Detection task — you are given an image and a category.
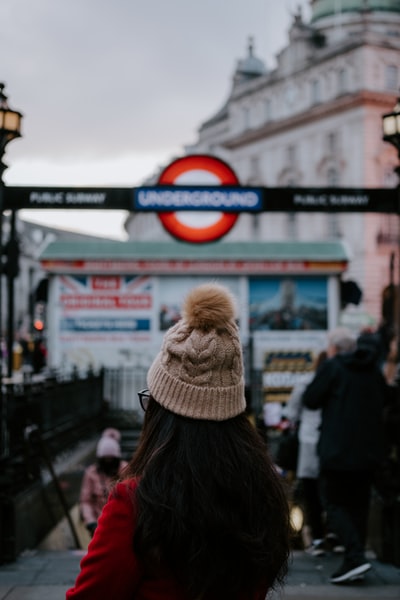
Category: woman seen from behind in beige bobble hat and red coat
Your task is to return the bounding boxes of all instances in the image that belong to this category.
[67,283,290,600]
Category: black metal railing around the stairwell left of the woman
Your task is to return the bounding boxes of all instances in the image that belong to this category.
[0,368,146,564]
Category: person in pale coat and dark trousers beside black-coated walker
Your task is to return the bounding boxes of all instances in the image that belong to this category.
[286,350,328,556]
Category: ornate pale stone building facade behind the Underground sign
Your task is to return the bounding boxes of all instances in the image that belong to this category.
[126,0,400,321]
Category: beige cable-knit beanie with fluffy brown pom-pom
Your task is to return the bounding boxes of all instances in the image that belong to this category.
[147,283,246,421]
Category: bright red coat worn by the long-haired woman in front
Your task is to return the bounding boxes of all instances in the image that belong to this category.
[66,481,266,600]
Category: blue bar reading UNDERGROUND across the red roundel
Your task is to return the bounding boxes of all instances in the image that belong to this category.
[134,185,262,212]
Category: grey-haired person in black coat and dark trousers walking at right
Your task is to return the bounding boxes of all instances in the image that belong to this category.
[303,328,388,583]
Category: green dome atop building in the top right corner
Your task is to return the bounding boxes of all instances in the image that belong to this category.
[311,0,400,23]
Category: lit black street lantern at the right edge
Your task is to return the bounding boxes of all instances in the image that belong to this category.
[382,98,400,378]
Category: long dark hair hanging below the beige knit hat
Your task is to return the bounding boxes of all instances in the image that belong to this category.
[120,399,290,600]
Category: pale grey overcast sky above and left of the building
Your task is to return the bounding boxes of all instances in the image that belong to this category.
[0,0,309,239]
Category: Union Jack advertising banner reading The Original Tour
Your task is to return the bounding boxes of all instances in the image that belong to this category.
[54,275,154,368]
